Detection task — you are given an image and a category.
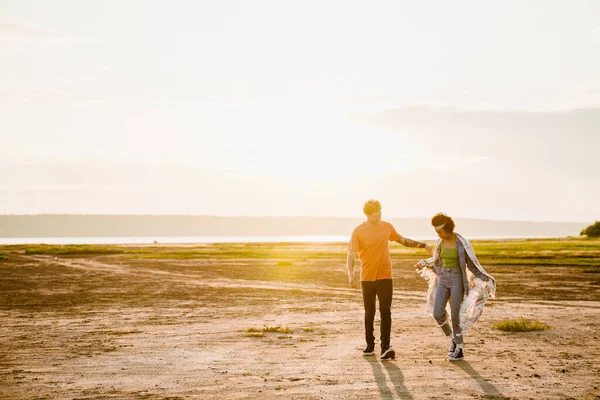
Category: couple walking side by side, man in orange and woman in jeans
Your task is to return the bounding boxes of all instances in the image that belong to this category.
[346,200,496,361]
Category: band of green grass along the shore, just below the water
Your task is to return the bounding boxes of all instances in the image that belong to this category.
[5,237,600,267]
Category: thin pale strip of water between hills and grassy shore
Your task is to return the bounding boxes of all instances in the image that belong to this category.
[0,235,547,245]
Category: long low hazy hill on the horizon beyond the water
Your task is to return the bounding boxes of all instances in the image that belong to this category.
[0,215,588,238]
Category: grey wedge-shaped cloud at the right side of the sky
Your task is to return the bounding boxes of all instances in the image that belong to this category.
[353,106,600,179]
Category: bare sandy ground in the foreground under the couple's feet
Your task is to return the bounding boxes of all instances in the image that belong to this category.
[0,247,600,400]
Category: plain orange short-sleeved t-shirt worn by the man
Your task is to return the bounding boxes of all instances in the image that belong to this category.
[348,221,401,281]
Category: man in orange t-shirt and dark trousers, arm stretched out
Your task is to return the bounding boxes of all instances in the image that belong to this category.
[346,200,431,360]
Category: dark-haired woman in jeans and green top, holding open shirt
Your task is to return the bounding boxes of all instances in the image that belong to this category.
[415,213,496,361]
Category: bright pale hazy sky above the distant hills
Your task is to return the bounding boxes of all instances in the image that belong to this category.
[0,0,600,222]
